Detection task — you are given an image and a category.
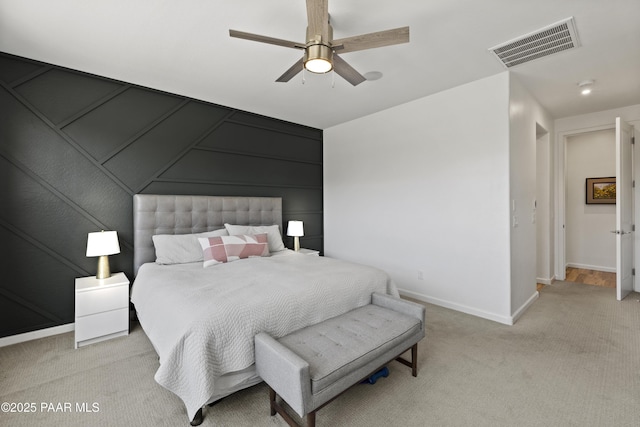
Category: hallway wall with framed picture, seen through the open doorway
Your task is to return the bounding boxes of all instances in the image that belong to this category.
[565,129,616,272]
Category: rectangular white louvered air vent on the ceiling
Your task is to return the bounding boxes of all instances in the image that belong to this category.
[489,17,580,68]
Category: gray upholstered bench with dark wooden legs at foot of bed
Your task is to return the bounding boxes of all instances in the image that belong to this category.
[255,293,425,427]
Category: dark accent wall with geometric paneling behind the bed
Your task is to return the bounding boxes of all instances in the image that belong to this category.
[0,53,323,337]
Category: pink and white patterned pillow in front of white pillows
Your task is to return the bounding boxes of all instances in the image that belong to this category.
[198,233,269,267]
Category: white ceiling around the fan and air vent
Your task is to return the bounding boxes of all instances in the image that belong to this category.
[0,0,640,129]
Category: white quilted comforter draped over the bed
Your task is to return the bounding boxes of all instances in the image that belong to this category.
[131,251,398,419]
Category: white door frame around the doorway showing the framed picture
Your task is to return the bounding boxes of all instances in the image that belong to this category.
[554,120,616,280]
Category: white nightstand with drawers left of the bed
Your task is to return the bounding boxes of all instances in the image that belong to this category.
[75,273,129,348]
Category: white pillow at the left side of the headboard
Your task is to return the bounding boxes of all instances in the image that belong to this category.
[152,228,229,264]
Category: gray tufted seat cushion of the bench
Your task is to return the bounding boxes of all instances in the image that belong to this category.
[278,305,422,394]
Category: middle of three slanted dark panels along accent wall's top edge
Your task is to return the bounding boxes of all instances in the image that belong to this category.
[63,87,182,161]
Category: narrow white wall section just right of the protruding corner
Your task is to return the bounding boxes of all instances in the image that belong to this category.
[508,74,553,319]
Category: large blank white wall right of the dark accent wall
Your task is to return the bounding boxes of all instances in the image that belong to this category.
[324,72,516,324]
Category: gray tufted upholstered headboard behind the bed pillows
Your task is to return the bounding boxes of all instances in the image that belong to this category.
[133,194,282,274]
